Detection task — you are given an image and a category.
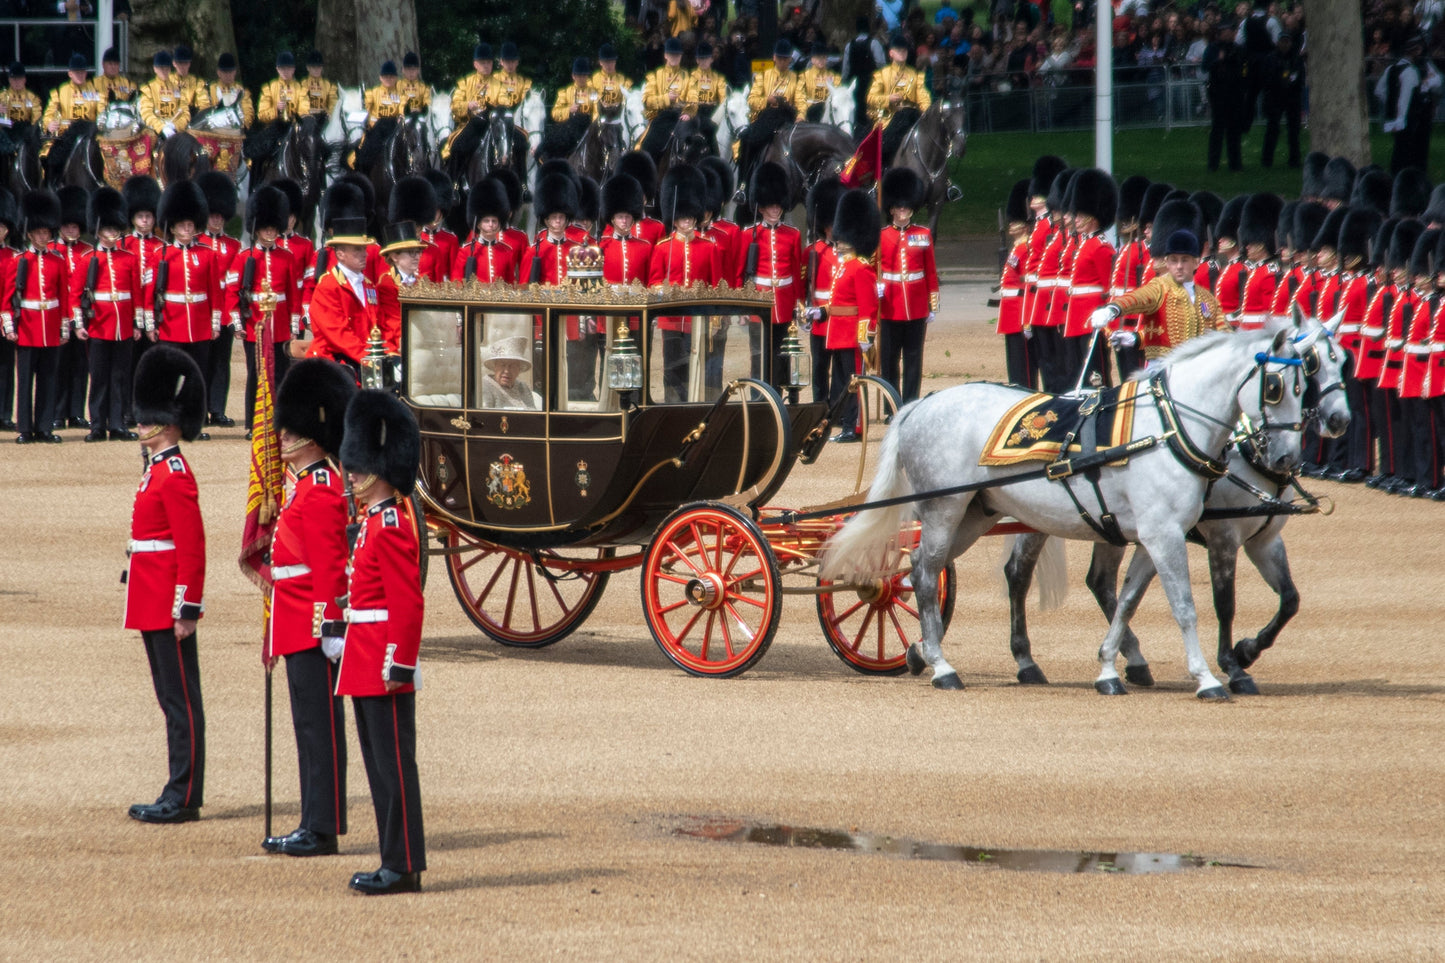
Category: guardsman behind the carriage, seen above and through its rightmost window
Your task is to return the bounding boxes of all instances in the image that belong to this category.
[647,163,719,402]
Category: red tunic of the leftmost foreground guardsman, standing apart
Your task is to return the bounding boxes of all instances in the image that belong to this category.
[126,445,205,632]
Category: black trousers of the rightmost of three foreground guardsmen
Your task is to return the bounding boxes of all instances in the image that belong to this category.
[351,693,426,873]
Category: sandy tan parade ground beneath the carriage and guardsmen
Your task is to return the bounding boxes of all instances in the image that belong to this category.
[0,282,1445,960]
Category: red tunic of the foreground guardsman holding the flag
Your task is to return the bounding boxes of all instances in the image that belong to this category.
[263,461,350,659]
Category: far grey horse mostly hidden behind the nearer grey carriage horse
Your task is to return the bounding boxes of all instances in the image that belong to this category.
[1004,308,1350,696]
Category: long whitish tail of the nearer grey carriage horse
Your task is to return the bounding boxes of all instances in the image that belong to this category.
[818,408,913,581]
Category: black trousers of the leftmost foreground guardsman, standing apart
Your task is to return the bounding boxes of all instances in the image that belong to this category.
[140,629,205,808]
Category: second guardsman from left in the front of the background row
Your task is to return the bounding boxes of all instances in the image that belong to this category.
[71,187,142,441]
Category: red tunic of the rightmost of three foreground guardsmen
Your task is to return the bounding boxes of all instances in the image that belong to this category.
[336,494,423,696]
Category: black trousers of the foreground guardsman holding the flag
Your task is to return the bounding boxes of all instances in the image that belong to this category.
[286,648,347,836]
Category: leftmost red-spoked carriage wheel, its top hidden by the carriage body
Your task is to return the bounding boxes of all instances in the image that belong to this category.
[447,528,613,649]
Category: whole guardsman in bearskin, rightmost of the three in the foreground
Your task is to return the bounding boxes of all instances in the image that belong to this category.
[337,390,426,895]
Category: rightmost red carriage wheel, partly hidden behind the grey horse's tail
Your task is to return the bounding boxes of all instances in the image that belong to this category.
[818,564,958,675]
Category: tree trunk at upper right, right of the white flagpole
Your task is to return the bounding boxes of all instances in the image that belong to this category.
[1305,0,1370,166]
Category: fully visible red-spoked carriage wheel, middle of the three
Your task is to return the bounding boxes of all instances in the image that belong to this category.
[642,505,783,678]
